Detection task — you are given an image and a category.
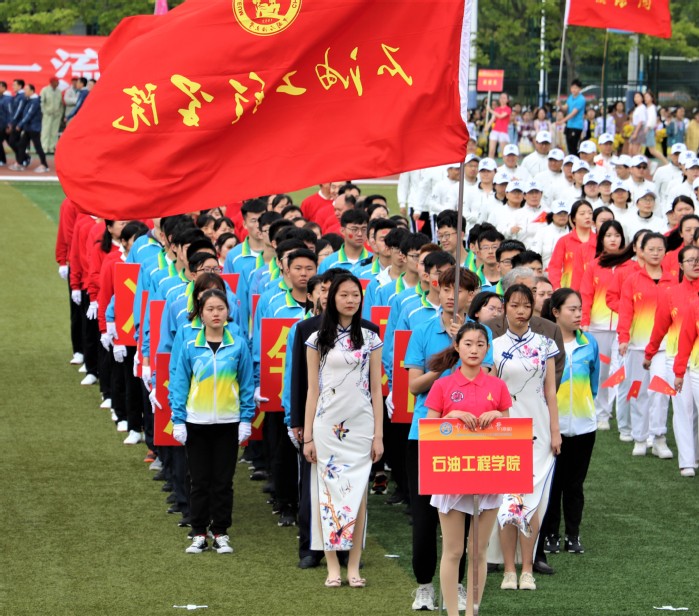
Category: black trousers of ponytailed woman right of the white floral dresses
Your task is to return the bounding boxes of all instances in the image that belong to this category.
[541,432,597,536]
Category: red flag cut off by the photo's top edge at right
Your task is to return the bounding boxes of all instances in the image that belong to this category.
[566,0,672,38]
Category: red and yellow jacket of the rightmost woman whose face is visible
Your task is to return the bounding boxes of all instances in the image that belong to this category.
[646,270,699,359]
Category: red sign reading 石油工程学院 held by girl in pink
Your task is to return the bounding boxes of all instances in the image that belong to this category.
[418,418,534,494]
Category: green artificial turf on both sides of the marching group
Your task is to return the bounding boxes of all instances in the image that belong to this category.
[0,179,699,616]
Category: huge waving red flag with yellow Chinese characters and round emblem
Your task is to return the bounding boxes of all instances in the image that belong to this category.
[56,0,471,219]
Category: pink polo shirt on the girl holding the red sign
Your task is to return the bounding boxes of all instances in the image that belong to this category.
[425,369,512,417]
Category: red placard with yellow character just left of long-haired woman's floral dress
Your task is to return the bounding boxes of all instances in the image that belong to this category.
[260,318,298,412]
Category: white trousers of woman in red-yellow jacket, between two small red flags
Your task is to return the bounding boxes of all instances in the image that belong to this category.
[619,349,669,443]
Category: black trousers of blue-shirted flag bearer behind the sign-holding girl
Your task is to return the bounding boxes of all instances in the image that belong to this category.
[406,441,471,584]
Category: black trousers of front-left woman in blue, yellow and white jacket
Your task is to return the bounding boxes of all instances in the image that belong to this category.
[185,423,239,535]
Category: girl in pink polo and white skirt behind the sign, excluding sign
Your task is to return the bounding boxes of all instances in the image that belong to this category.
[425,321,512,616]
